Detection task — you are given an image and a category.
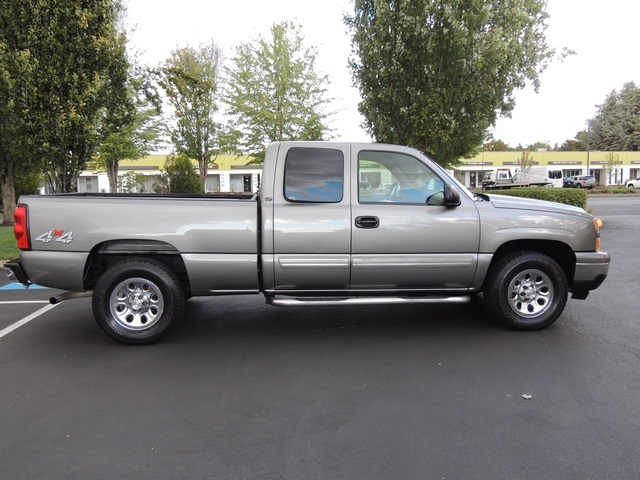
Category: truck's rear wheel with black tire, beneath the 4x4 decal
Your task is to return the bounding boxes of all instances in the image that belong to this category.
[92,258,185,344]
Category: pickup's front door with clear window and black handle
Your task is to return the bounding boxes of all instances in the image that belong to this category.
[350,145,480,293]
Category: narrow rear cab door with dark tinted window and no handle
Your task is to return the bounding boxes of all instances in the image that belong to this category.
[267,144,351,293]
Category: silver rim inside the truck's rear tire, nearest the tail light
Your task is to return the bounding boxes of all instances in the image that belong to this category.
[109,278,164,330]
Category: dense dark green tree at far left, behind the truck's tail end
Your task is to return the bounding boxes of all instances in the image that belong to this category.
[2,0,125,192]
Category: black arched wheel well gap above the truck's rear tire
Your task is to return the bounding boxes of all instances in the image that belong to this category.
[84,240,191,298]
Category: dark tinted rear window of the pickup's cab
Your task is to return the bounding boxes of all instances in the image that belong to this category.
[284,148,344,203]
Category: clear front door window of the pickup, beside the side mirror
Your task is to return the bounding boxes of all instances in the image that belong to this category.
[358,151,444,205]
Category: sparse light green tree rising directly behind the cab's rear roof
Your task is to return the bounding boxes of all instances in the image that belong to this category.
[226,22,331,162]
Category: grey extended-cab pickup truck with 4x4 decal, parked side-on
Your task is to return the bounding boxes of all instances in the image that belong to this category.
[5,142,609,343]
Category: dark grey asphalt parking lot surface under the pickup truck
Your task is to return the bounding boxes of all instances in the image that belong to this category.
[0,195,640,480]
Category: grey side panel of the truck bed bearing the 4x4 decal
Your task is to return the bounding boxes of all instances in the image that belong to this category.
[20,195,258,295]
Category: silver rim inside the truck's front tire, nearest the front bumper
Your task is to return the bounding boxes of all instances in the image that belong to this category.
[509,269,555,318]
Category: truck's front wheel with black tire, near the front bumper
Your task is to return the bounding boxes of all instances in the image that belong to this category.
[484,251,568,330]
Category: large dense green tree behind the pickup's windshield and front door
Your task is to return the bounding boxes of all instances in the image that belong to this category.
[345,0,553,166]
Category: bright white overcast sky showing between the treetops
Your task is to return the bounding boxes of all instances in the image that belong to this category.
[125,0,640,147]
